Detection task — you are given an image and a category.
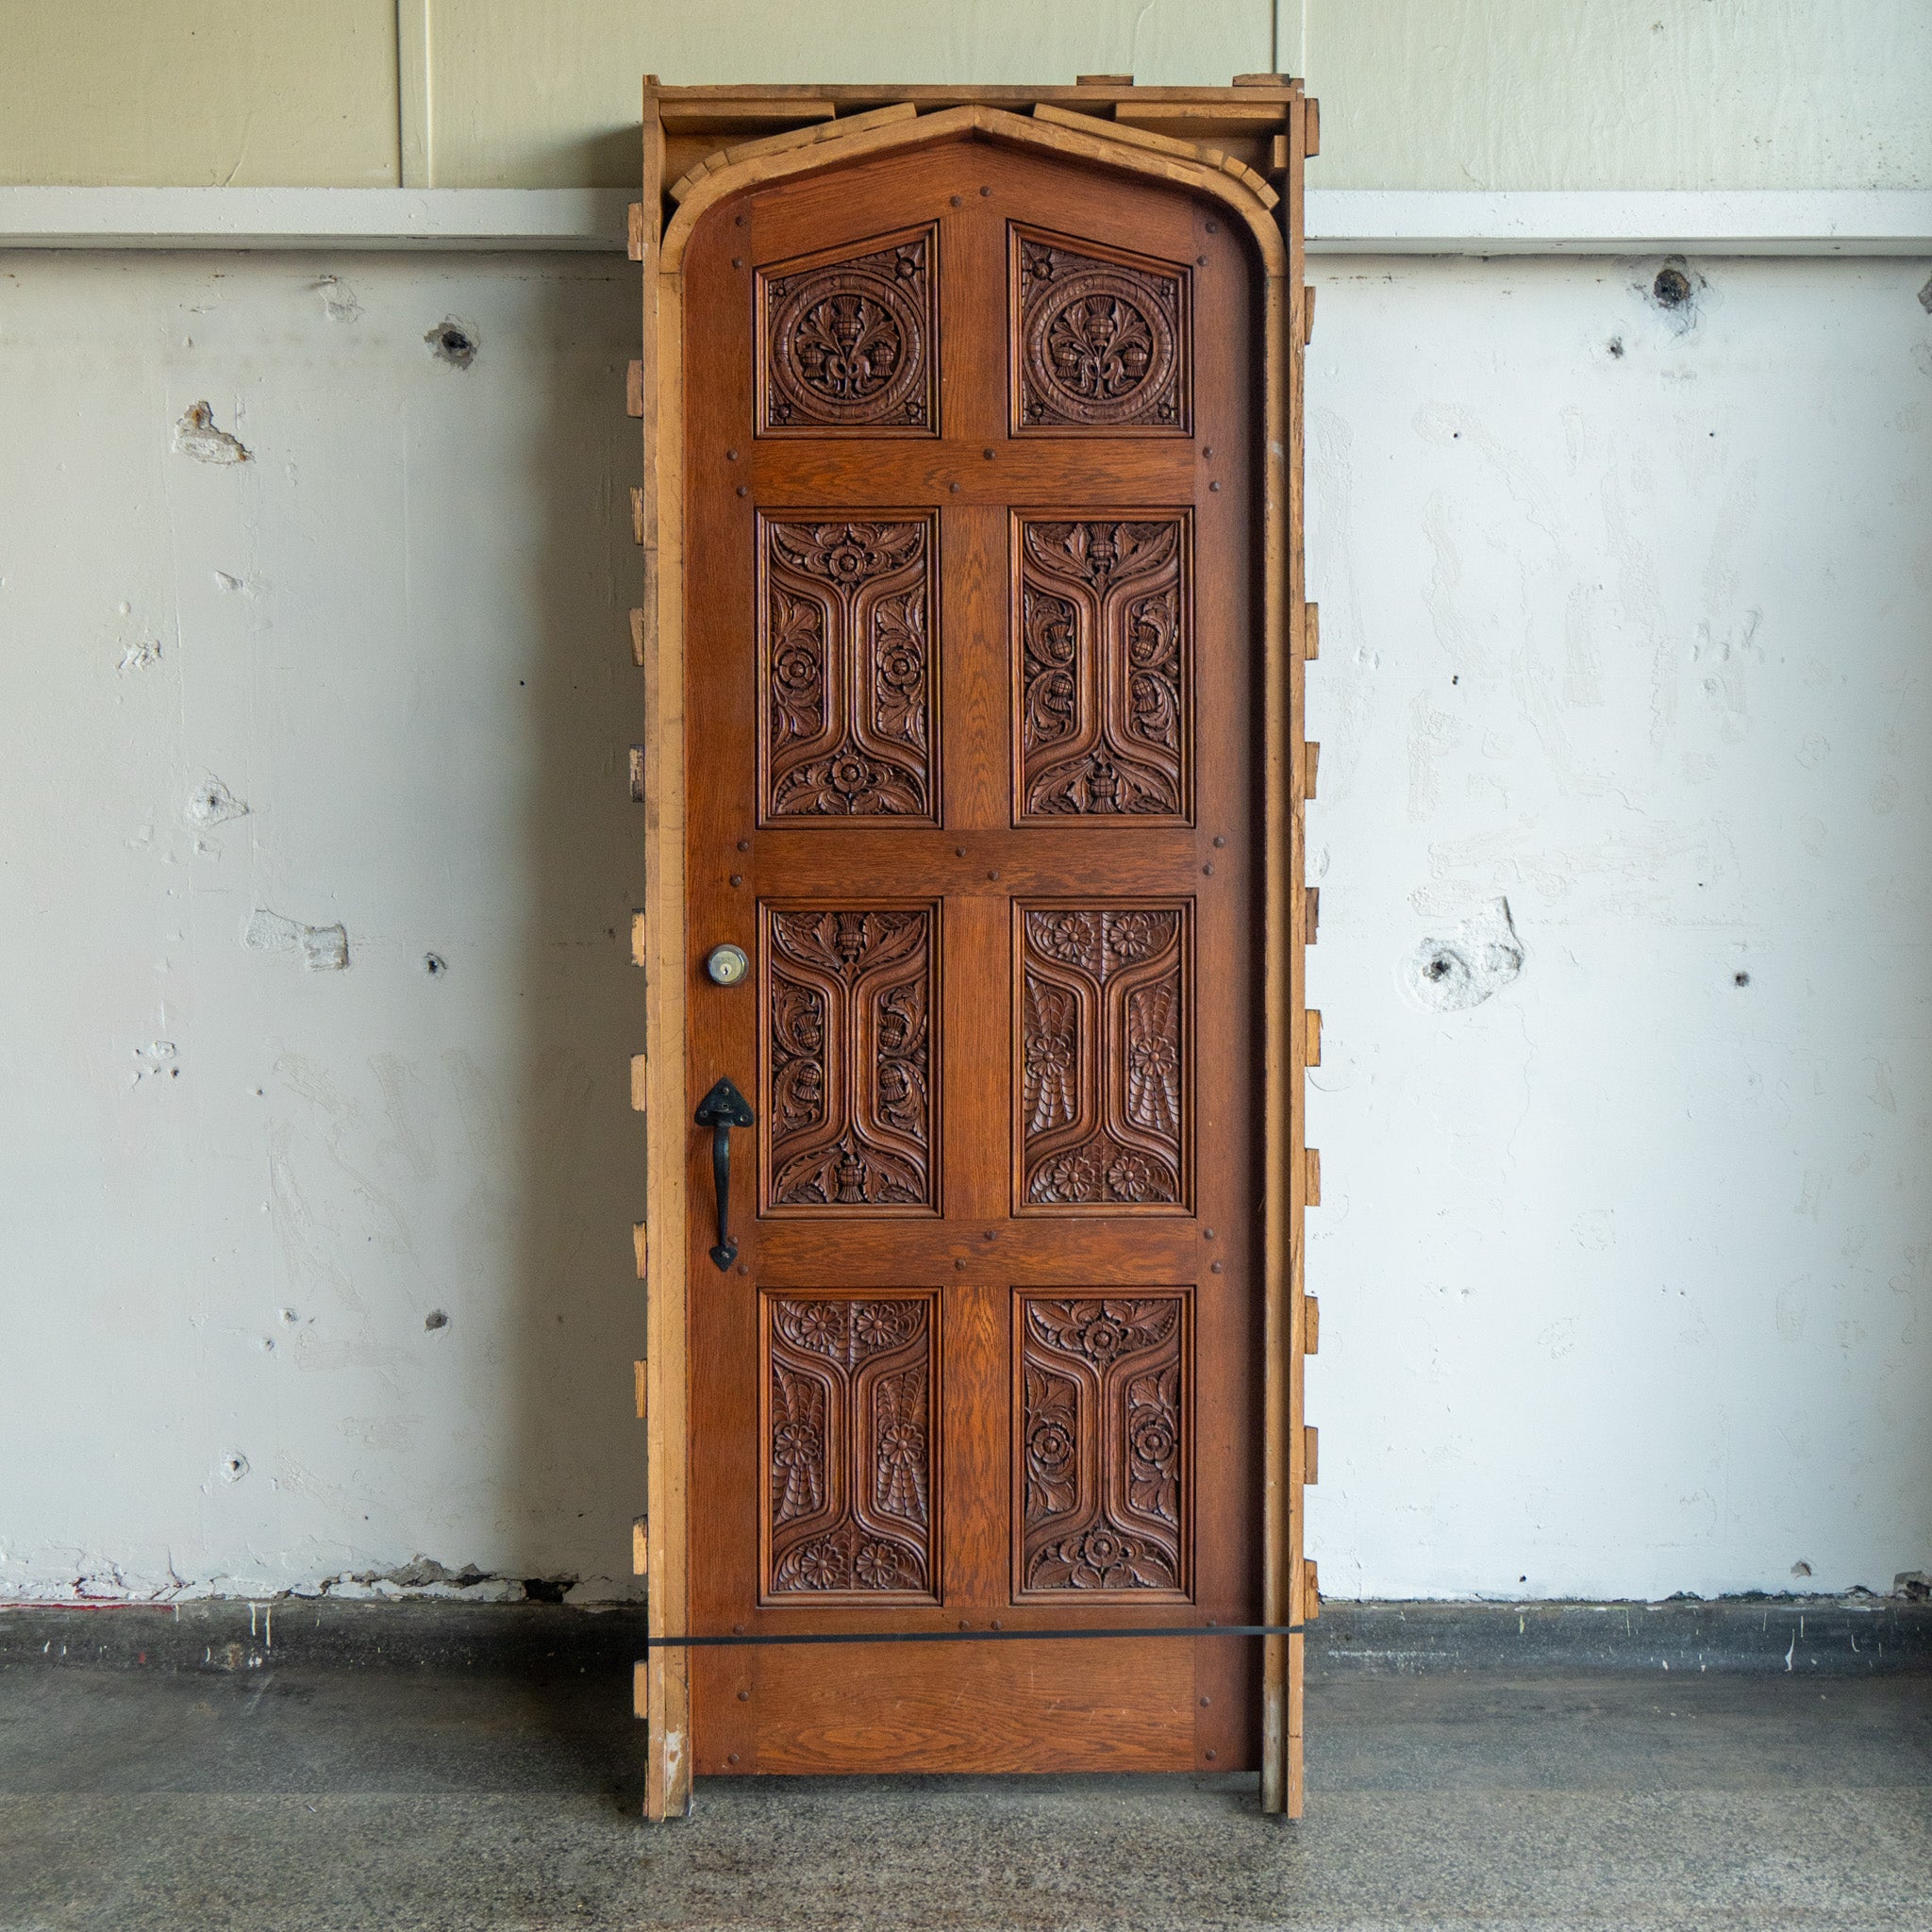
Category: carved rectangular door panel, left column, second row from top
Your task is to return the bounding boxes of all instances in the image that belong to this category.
[758,512,939,824]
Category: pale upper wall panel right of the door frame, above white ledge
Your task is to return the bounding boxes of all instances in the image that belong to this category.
[1283,0,1932,188]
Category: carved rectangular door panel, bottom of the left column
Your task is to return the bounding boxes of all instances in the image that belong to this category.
[761,1292,939,1604]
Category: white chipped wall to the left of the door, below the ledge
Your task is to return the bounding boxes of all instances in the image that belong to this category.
[0,255,643,1596]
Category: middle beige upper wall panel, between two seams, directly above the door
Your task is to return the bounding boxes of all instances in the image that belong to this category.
[431,0,1272,188]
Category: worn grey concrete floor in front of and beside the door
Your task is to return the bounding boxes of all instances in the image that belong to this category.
[0,1665,1932,1932]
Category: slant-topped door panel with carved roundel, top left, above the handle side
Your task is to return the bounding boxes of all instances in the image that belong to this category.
[758,225,939,437]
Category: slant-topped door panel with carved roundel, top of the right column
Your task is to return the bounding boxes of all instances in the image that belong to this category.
[1007,225,1194,437]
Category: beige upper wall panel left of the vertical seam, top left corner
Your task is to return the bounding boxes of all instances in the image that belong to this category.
[0,0,396,188]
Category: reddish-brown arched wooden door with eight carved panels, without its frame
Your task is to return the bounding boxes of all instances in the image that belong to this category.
[684,128,1263,1774]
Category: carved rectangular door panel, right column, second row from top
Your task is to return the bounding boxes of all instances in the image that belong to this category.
[1012,510,1194,824]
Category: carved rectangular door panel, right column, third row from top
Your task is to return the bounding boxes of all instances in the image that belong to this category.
[1012,900,1194,1213]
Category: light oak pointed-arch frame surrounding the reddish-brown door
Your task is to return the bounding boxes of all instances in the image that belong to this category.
[630,75,1320,1820]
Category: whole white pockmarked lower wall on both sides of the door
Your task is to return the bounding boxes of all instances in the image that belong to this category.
[0,242,1932,1598]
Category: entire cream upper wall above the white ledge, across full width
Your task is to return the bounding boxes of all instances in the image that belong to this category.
[0,0,1932,188]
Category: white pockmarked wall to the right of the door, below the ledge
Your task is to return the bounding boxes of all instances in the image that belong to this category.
[1307,245,1932,1598]
